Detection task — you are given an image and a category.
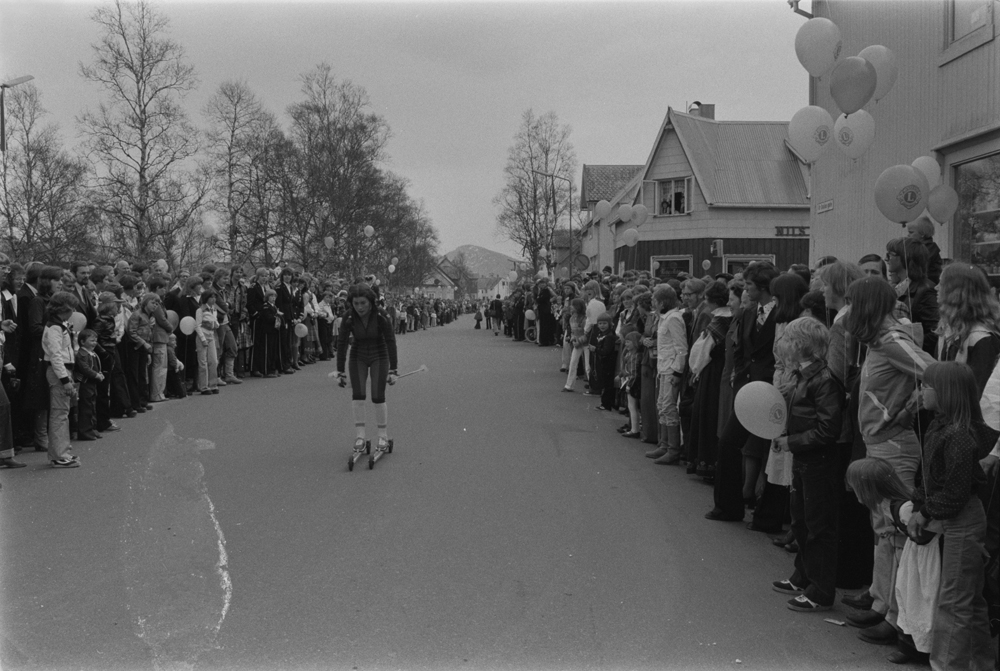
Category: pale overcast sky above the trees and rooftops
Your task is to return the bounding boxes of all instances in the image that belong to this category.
[0,0,808,255]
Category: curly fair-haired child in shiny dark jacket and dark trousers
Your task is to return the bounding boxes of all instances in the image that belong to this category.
[772,317,844,613]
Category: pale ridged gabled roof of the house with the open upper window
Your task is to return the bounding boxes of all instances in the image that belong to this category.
[643,108,809,209]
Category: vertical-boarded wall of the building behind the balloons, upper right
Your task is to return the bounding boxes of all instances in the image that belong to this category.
[802,0,1000,268]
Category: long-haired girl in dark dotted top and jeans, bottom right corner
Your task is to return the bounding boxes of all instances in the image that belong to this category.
[907,361,1000,671]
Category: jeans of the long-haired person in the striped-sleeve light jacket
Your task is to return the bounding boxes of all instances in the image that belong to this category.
[865,430,920,626]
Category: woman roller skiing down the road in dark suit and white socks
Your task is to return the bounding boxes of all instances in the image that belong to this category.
[337,283,397,468]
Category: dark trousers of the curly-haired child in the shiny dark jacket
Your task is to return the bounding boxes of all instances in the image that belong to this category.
[791,454,844,606]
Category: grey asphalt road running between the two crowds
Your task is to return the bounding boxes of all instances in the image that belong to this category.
[0,317,891,671]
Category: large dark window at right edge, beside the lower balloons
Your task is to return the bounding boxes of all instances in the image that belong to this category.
[955,153,1000,277]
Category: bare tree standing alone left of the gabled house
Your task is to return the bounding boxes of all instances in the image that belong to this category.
[493,109,576,271]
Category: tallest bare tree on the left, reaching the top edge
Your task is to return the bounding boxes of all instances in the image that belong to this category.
[79,0,206,258]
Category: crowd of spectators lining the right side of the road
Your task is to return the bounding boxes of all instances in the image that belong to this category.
[479,221,1000,671]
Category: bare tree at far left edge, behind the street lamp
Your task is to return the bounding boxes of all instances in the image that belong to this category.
[0,84,93,261]
